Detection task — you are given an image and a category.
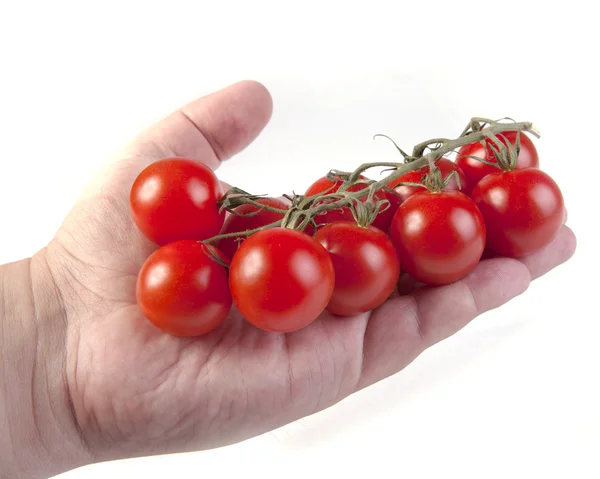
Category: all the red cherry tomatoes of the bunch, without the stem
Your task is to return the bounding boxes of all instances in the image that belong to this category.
[130,127,564,336]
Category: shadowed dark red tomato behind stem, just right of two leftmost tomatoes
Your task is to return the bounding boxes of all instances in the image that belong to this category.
[217,198,289,259]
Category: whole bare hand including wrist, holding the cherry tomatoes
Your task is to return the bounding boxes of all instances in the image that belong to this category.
[0,82,576,479]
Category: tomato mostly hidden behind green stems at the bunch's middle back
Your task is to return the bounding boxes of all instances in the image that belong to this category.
[305,175,398,231]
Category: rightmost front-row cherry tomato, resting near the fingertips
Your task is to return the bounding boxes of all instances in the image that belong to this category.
[471,168,564,258]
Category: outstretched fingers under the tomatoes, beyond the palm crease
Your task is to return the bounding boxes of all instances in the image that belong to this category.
[359,226,575,388]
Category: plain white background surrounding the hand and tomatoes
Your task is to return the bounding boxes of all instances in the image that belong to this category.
[0,0,600,479]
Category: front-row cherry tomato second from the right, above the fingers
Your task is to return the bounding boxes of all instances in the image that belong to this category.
[390,191,485,285]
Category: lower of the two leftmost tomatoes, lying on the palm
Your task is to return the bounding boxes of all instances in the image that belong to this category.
[136,240,231,336]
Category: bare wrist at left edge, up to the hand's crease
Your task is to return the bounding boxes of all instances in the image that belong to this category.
[0,250,90,479]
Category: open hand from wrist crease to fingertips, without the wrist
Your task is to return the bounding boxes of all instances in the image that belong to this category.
[43,82,575,460]
